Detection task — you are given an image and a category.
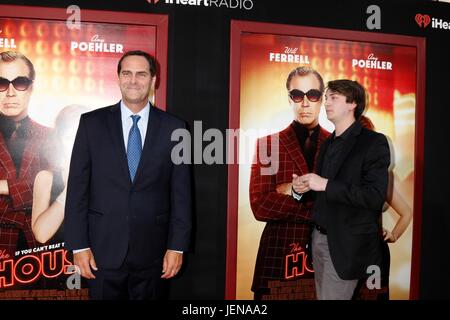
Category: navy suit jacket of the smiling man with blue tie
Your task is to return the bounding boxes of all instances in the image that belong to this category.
[64,103,191,268]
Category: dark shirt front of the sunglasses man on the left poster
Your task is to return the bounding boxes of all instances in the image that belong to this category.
[0,115,30,176]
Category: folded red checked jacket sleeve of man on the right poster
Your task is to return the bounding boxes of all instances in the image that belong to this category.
[249,136,312,222]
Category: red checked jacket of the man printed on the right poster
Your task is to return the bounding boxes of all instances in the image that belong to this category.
[249,124,329,290]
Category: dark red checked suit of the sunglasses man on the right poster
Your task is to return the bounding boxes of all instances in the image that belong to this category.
[250,124,329,299]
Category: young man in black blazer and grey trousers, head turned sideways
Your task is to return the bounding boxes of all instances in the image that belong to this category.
[293,80,390,300]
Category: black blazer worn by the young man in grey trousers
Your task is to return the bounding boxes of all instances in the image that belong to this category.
[317,122,390,280]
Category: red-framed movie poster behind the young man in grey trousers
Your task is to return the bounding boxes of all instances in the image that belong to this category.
[227,21,424,300]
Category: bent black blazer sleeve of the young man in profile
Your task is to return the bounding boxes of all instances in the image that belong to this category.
[325,134,390,210]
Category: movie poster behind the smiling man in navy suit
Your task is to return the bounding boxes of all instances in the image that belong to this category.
[0,8,167,299]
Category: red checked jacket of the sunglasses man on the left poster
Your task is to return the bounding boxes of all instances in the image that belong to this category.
[0,119,50,256]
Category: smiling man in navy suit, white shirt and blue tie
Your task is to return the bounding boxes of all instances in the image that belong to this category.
[65,51,191,299]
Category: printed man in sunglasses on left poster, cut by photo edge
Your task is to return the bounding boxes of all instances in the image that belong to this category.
[0,51,50,257]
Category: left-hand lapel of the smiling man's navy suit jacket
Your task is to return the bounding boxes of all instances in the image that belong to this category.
[108,102,131,184]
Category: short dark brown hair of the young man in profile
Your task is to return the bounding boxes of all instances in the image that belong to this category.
[327,79,366,119]
